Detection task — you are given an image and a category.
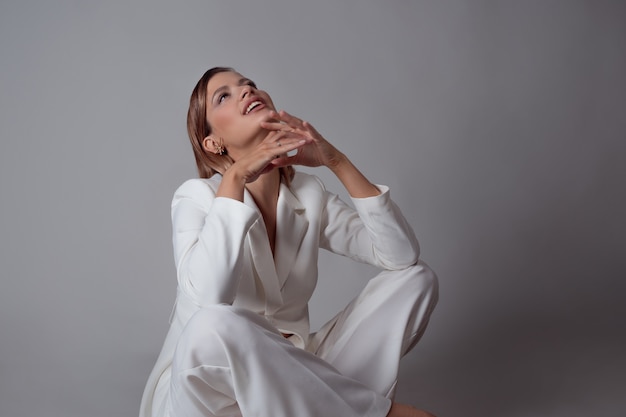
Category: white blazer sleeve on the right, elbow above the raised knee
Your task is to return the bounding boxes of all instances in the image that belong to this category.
[320,185,420,270]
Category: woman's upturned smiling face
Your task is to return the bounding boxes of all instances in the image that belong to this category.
[206,71,275,160]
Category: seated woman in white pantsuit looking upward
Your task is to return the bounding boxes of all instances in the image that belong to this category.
[140,68,437,417]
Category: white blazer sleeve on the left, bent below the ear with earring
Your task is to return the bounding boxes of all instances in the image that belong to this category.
[172,179,260,306]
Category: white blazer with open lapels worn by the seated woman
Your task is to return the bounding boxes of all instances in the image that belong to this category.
[140,172,419,417]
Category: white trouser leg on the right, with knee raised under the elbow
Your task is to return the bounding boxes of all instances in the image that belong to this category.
[307,262,438,398]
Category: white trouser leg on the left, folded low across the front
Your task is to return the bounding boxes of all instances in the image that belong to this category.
[170,305,390,417]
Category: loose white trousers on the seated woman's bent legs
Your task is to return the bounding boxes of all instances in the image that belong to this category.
[169,263,438,417]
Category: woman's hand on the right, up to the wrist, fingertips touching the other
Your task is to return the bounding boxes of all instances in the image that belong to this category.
[261,110,345,169]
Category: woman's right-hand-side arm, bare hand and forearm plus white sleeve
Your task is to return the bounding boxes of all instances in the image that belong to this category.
[261,111,419,269]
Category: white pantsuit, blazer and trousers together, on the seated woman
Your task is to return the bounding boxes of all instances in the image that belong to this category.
[140,173,437,417]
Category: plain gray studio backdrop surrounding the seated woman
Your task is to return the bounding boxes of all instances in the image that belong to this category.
[0,0,626,417]
